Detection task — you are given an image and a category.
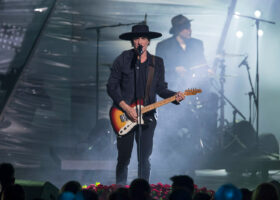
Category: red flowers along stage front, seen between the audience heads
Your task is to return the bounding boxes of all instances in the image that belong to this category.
[83,182,215,200]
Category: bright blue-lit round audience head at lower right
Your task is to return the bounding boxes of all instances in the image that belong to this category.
[215,184,242,200]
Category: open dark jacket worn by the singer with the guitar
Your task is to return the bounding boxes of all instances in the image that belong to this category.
[107,49,175,106]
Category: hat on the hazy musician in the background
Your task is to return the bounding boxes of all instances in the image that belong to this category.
[169,15,192,34]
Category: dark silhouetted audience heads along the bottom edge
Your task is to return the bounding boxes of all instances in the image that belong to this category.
[0,163,280,200]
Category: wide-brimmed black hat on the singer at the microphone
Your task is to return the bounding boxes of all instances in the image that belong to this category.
[119,24,162,40]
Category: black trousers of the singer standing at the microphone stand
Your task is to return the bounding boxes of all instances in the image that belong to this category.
[116,116,157,185]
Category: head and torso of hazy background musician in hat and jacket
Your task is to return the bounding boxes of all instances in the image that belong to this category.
[156,15,208,87]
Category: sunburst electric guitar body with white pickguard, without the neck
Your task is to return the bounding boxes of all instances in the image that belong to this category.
[110,103,144,136]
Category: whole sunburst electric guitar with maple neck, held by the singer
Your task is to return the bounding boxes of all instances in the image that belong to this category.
[110,89,202,136]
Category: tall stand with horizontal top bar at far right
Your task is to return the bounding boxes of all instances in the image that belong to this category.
[232,14,275,143]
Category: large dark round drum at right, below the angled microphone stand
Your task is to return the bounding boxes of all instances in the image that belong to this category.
[223,121,257,156]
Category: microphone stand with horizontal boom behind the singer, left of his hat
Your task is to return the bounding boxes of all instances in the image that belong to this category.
[86,14,147,124]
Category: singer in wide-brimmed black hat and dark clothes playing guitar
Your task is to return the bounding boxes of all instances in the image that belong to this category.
[107,25,184,184]
